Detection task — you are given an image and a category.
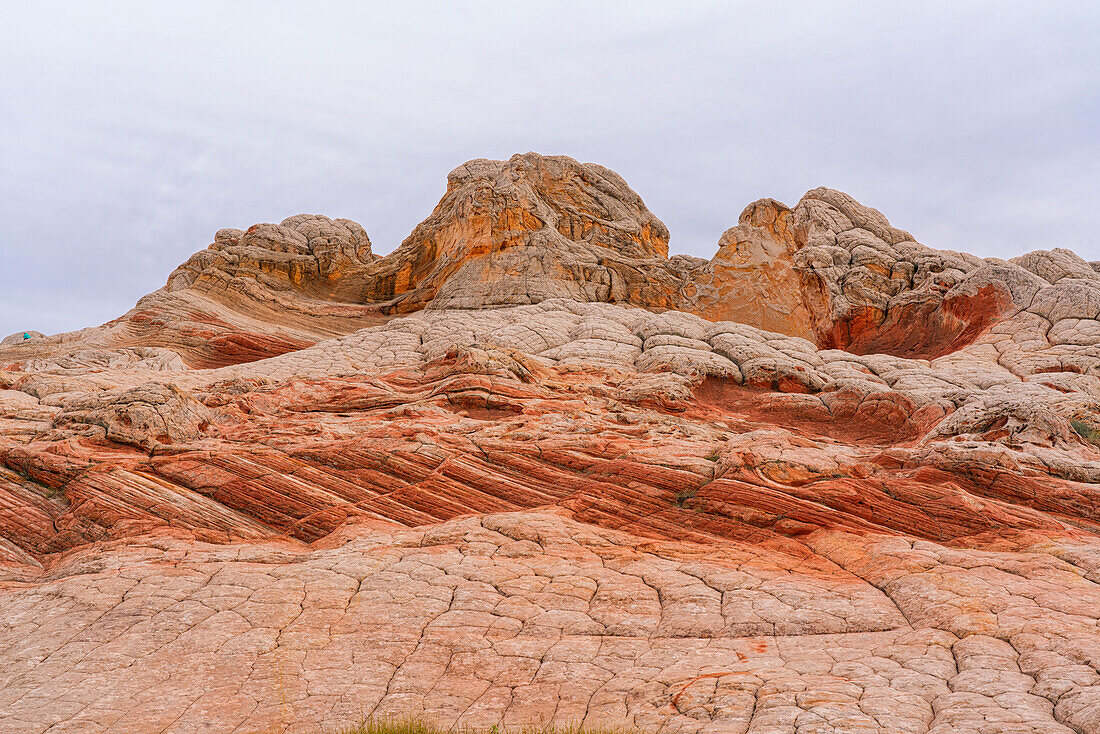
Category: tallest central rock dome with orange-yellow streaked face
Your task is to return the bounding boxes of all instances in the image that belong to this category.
[364,153,681,313]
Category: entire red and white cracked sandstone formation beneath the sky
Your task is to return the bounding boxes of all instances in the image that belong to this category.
[0,154,1100,734]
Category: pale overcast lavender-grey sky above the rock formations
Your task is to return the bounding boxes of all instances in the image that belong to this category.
[0,0,1100,337]
